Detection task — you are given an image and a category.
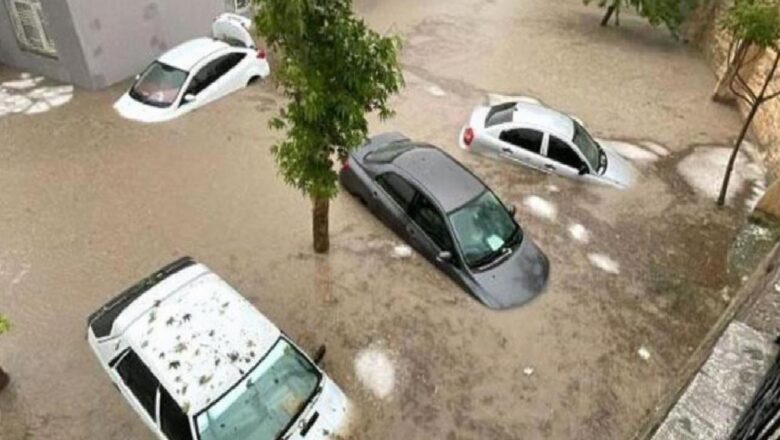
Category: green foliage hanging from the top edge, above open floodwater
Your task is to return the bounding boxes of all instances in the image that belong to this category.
[583,0,698,38]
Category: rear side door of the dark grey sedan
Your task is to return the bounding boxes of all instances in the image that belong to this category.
[374,172,417,241]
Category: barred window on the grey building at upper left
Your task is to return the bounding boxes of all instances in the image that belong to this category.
[6,0,57,57]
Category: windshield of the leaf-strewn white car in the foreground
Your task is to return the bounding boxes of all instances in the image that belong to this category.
[196,338,322,440]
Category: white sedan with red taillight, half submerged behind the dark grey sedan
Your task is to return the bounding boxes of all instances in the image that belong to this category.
[460,102,636,188]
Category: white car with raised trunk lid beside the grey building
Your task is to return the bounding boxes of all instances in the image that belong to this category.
[114,13,271,122]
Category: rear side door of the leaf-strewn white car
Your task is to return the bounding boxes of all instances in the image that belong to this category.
[114,349,165,439]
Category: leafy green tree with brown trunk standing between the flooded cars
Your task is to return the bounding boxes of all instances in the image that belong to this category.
[255,0,404,253]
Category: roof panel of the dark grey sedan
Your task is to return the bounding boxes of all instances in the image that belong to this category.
[393,144,485,212]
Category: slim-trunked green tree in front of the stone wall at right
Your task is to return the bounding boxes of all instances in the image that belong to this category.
[718,0,780,206]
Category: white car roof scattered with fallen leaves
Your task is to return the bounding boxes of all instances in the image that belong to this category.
[124,271,281,414]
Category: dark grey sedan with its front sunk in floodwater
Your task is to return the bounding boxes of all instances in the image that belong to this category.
[340,133,549,309]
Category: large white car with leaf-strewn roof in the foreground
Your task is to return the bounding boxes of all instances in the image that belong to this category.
[87,257,349,440]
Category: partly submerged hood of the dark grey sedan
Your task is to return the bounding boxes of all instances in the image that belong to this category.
[472,236,550,309]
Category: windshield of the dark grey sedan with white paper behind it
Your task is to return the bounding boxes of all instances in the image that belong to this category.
[449,191,522,268]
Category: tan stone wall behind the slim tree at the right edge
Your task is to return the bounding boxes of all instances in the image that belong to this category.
[684,0,780,181]
